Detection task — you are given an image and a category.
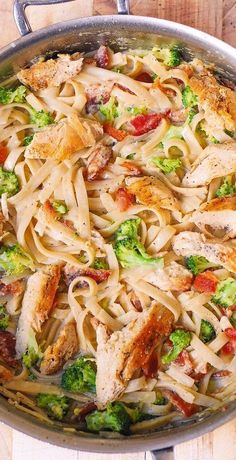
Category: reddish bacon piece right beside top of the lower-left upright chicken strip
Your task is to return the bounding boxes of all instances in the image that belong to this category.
[63,264,111,286]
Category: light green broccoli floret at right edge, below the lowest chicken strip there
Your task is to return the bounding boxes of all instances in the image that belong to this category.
[212,278,236,308]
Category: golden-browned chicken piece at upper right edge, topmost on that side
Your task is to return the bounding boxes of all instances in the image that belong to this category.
[189,73,236,135]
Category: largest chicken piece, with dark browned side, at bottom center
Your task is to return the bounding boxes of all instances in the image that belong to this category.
[96,303,174,409]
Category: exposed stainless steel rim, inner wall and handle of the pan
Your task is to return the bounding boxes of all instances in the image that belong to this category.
[0,0,236,452]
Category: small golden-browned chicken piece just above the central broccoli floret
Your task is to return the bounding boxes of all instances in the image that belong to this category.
[127,176,179,211]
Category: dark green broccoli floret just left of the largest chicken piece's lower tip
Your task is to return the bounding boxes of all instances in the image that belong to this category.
[61,356,96,393]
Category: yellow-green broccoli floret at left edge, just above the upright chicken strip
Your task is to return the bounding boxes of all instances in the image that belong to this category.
[0,244,34,275]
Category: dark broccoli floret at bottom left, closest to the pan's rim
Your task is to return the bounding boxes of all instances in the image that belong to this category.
[37,393,70,420]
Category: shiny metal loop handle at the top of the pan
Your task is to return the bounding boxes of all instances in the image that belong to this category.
[13,0,129,35]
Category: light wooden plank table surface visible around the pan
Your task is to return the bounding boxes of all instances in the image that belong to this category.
[0,0,236,460]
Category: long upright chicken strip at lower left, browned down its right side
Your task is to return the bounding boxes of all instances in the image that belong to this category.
[16,265,61,356]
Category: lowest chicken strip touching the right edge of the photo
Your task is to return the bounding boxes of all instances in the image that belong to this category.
[173,232,236,273]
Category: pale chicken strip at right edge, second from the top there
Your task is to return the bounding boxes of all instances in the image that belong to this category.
[182,142,236,187]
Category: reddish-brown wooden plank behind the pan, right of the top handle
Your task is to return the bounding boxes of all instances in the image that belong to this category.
[93,0,223,37]
